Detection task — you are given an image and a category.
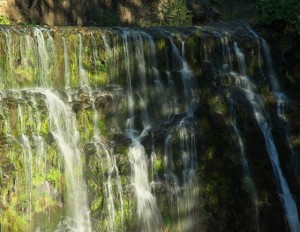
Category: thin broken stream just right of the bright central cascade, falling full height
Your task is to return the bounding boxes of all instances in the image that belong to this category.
[170,39,199,231]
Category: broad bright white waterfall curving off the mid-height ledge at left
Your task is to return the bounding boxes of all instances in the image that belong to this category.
[41,90,91,232]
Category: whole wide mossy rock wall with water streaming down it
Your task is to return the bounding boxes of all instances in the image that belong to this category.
[0,24,300,232]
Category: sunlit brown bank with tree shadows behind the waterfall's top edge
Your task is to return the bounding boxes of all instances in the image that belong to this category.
[0,0,191,26]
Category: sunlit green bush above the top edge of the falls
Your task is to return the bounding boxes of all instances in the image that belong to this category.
[157,0,192,26]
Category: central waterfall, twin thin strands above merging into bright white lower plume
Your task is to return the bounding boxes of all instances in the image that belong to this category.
[123,31,161,232]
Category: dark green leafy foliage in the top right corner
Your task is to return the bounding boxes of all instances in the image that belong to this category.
[255,0,300,35]
